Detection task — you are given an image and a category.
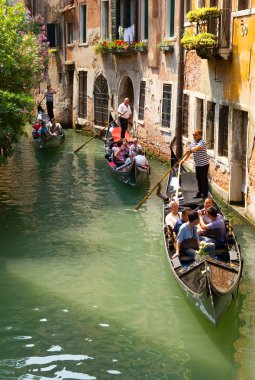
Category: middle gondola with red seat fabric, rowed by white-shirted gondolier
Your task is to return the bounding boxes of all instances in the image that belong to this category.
[104,126,150,187]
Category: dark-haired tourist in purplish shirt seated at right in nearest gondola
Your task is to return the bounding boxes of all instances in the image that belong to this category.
[199,207,226,248]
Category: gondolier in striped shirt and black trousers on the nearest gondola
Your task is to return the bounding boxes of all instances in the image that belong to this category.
[185,129,209,198]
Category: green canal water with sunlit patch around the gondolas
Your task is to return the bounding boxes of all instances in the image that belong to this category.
[0,131,255,380]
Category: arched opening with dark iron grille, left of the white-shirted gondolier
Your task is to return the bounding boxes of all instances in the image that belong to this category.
[94,74,109,127]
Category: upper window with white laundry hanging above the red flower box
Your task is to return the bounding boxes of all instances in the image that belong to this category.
[111,0,138,42]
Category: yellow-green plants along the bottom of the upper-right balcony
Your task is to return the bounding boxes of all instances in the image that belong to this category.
[181,33,218,50]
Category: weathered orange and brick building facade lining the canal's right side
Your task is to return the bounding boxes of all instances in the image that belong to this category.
[25,0,255,220]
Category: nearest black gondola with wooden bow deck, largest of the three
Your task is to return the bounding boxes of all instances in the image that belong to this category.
[163,168,243,325]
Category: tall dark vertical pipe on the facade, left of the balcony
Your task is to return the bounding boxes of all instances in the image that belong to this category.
[175,1,184,159]
